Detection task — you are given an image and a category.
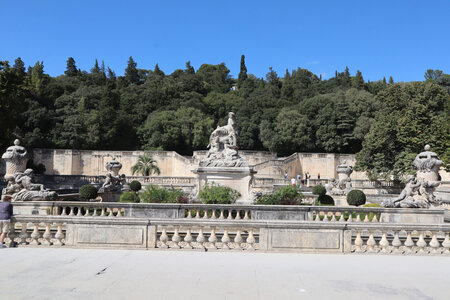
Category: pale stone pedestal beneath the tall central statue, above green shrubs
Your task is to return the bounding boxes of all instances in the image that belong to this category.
[192,167,256,204]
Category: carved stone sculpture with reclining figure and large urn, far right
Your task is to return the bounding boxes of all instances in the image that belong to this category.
[381,145,443,208]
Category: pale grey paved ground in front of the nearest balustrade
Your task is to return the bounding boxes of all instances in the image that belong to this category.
[0,248,450,300]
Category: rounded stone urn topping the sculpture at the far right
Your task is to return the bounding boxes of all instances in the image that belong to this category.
[413,145,443,183]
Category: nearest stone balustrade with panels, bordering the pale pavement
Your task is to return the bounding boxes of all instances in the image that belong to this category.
[6,215,450,255]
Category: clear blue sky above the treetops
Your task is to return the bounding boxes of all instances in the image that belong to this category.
[0,0,450,81]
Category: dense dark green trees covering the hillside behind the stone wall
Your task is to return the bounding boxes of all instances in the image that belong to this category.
[0,56,450,178]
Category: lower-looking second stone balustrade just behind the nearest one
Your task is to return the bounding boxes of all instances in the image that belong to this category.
[13,201,445,224]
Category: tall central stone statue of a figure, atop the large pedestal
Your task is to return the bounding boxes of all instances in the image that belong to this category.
[200,112,248,167]
